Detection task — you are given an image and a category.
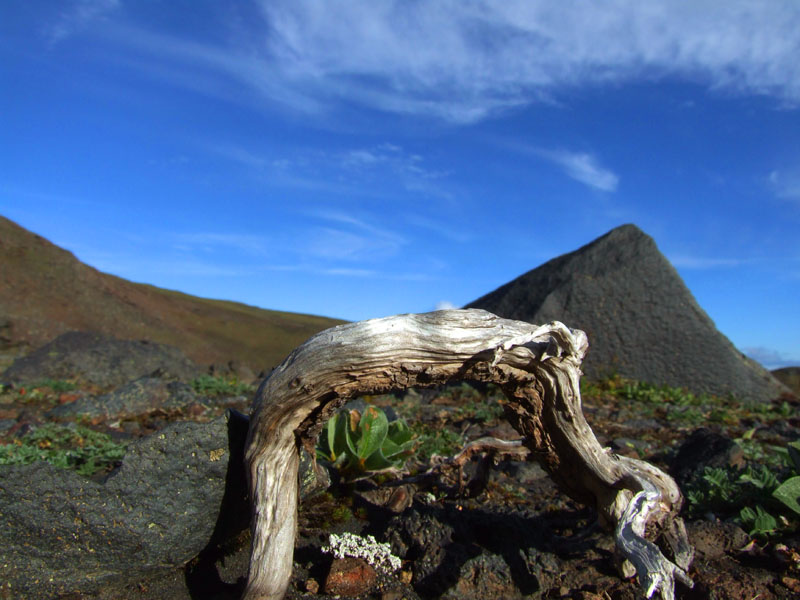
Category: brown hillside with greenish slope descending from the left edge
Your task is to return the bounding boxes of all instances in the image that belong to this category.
[0,217,343,372]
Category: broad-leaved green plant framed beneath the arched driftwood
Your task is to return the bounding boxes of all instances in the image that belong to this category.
[317,406,416,480]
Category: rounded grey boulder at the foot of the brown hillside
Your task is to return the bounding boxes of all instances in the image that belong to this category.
[3,331,200,389]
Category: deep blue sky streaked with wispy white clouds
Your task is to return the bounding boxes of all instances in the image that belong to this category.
[0,0,800,367]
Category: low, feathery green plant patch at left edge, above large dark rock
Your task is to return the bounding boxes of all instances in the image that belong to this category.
[0,423,125,476]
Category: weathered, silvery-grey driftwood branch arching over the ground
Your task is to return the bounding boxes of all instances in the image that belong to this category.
[244,310,691,600]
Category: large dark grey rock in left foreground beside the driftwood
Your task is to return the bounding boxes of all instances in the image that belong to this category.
[0,412,249,598]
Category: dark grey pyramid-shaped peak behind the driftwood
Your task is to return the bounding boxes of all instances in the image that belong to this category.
[467,225,788,400]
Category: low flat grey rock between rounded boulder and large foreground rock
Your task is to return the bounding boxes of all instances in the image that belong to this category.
[47,377,198,418]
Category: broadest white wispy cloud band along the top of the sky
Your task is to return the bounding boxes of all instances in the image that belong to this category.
[57,0,800,123]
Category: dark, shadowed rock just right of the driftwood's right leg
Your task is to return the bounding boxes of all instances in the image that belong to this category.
[671,427,744,488]
